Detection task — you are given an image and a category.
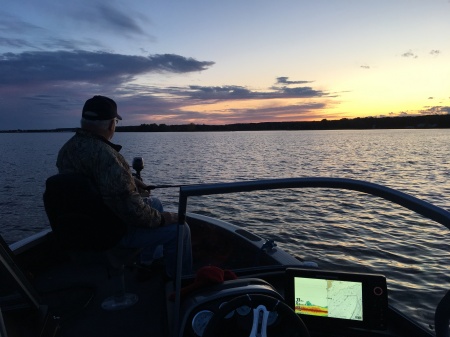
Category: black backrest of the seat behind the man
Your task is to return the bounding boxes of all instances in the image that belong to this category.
[43,173,126,251]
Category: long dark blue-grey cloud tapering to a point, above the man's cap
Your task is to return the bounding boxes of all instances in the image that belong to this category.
[0,51,214,85]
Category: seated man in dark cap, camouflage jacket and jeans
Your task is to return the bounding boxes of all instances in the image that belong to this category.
[56,96,192,276]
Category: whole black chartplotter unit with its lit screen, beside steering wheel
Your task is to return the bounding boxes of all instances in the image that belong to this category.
[285,268,388,330]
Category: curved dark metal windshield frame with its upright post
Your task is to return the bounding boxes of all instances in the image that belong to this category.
[173,177,450,336]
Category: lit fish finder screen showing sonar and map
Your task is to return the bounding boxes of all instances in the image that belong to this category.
[294,277,363,321]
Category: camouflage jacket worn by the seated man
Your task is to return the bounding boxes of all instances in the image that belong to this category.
[56,129,162,227]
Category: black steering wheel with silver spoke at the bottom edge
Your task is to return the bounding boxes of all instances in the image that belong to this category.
[203,294,309,337]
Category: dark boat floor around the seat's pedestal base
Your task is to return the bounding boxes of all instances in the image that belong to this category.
[29,263,168,337]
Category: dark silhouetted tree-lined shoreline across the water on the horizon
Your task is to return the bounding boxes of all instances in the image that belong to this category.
[0,114,450,133]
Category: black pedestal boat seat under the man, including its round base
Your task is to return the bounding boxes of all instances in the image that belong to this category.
[43,173,140,310]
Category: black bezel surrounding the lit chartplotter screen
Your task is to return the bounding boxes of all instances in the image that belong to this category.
[285,268,388,330]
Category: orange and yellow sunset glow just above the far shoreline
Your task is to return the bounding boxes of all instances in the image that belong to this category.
[130,93,450,125]
